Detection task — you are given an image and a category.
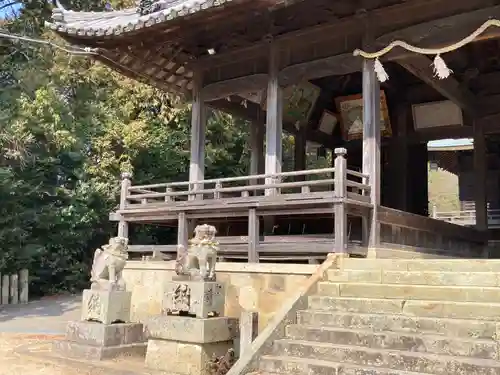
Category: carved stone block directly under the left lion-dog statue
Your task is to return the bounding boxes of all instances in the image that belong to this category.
[82,289,132,324]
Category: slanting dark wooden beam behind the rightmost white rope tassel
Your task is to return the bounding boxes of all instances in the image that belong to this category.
[397,55,478,115]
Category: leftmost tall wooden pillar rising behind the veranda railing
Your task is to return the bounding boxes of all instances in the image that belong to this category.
[189,70,207,190]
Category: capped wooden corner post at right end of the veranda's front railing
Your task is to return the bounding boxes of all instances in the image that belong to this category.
[334,148,347,253]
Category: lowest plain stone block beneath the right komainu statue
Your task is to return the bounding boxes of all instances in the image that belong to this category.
[145,339,233,375]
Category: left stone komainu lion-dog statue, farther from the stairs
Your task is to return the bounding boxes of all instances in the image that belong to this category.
[90,237,128,291]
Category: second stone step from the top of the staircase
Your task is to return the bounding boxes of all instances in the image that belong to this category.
[327,269,500,287]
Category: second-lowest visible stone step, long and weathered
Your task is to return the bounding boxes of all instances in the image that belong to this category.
[273,339,500,375]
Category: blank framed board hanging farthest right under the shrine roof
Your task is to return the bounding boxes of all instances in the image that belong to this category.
[412,100,463,130]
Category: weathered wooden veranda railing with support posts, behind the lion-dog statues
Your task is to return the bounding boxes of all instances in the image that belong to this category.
[117,149,371,261]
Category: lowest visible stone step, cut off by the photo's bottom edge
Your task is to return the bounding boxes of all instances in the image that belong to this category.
[257,355,424,375]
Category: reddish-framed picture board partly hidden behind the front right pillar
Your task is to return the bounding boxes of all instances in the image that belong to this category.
[335,90,392,141]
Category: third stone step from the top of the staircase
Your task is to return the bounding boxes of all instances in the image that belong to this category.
[318,282,500,302]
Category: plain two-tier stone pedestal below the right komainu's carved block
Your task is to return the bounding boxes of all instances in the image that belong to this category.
[146,315,238,375]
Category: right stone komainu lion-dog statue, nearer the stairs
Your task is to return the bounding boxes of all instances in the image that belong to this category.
[175,224,219,281]
